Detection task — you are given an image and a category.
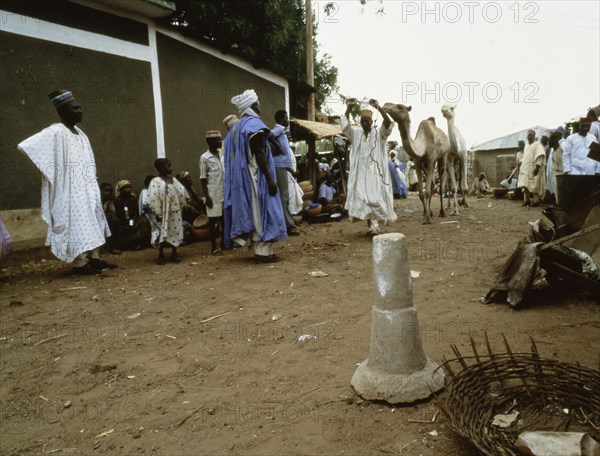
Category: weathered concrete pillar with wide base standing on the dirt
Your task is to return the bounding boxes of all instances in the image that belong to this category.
[350,233,444,404]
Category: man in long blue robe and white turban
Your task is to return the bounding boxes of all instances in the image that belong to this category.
[225,89,287,262]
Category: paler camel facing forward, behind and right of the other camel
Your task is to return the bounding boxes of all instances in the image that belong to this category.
[442,103,469,215]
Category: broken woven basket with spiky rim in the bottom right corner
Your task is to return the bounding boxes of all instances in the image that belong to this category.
[435,334,600,456]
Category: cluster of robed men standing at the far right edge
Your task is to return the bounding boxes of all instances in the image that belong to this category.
[516,109,600,207]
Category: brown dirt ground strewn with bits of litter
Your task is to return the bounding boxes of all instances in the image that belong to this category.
[0,195,600,456]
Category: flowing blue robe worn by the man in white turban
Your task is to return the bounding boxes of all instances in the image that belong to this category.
[223,115,287,247]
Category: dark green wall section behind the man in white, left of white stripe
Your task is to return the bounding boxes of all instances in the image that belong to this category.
[0,32,156,210]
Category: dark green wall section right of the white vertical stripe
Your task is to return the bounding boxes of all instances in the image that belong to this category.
[157,33,286,182]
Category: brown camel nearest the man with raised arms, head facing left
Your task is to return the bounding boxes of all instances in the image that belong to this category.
[383,103,450,224]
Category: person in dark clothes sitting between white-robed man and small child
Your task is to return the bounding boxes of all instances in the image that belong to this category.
[114,180,150,250]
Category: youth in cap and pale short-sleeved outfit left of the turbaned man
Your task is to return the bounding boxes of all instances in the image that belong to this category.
[200,130,225,255]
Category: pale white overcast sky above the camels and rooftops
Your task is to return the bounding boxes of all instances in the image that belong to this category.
[313,0,600,147]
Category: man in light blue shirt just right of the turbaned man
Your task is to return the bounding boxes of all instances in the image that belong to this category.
[271,110,300,236]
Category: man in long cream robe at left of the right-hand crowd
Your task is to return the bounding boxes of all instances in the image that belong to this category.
[517,130,546,207]
